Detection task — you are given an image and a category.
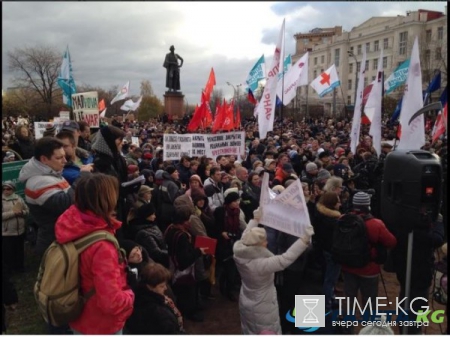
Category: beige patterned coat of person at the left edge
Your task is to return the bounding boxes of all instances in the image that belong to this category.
[2,193,30,236]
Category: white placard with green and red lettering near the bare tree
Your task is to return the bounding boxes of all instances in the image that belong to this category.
[72,91,100,128]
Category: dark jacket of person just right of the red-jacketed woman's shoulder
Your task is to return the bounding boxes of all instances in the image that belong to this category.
[134,221,170,268]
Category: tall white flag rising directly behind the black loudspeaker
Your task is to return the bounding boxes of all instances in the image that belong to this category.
[397,36,425,150]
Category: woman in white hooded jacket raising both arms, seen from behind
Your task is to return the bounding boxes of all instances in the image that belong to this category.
[233,208,314,335]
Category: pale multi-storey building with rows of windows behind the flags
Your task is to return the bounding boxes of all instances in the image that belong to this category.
[292,6,447,114]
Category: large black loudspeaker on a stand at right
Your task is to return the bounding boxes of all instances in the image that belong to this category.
[381,150,443,231]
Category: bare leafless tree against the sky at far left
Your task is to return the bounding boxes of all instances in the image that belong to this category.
[7,46,62,116]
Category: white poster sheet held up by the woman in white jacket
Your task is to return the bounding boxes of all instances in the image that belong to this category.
[259,173,311,237]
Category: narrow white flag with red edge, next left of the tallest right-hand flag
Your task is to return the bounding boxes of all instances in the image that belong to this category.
[361,49,383,156]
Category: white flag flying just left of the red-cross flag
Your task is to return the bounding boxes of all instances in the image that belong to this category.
[277,53,309,105]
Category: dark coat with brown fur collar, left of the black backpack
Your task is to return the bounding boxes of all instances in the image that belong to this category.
[312,203,341,252]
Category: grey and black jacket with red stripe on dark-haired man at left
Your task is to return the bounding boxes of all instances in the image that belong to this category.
[19,157,76,254]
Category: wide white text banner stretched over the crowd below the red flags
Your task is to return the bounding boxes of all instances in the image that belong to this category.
[163,131,245,160]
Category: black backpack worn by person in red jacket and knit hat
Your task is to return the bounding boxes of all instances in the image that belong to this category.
[331,214,370,268]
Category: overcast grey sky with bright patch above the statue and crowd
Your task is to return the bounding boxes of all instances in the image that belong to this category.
[2,1,446,104]
